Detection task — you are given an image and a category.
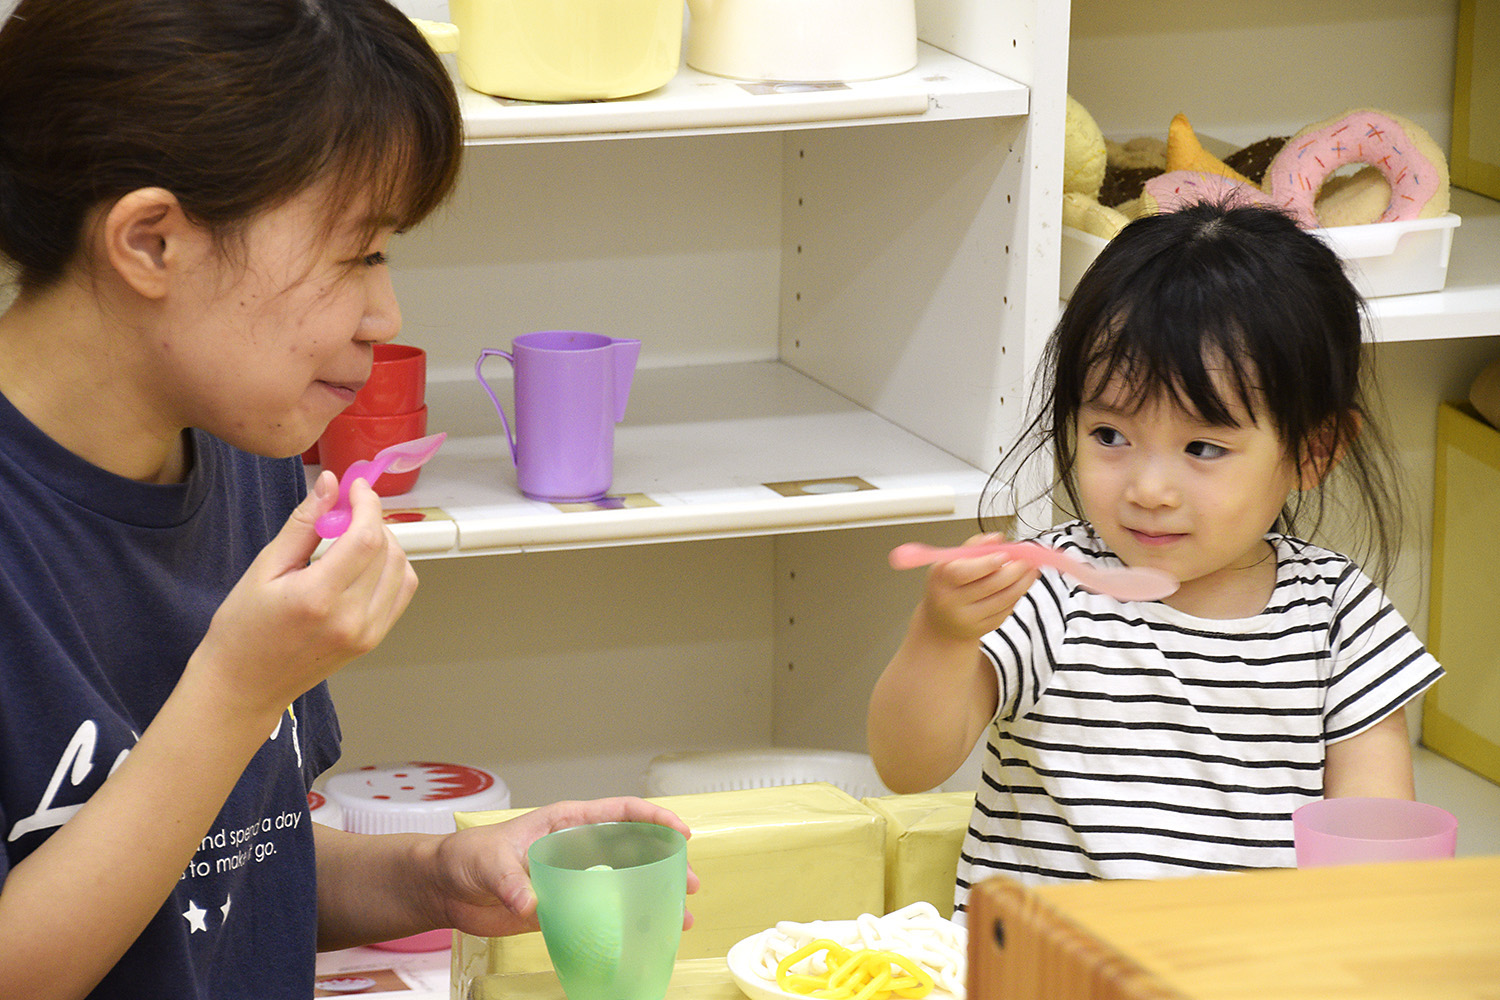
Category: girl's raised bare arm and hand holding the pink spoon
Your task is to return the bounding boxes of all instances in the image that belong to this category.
[866,535,1037,792]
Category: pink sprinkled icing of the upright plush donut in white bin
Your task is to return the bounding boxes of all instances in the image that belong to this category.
[1265,108,1448,228]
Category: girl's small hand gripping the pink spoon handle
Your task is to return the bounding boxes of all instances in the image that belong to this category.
[918,534,1038,642]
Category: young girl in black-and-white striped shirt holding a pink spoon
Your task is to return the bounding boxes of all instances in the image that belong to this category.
[869,205,1442,909]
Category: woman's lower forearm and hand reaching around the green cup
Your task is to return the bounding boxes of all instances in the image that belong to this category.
[314,798,698,949]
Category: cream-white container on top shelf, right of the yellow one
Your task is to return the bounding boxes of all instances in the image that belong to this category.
[687,0,917,82]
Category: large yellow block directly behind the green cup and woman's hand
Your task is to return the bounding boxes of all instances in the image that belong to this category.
[453,783,885,982]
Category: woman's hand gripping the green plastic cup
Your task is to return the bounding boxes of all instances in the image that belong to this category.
[420,798,698,937]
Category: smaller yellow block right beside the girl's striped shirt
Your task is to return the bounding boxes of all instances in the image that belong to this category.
[863,792,974,918]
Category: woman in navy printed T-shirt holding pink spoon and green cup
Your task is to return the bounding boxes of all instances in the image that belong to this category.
[0,0,683,1000]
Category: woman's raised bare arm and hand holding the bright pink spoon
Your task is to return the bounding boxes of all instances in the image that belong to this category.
[0,474,416,1000]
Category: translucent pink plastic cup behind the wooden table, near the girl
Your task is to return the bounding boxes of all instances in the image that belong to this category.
[1292,798,1458,868]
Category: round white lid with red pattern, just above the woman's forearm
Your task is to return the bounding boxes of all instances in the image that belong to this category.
[324,760,510,834]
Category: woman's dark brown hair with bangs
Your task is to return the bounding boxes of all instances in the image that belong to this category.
[0,0,464,294]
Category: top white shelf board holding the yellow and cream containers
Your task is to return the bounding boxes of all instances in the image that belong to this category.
[456,42,1031,142]
